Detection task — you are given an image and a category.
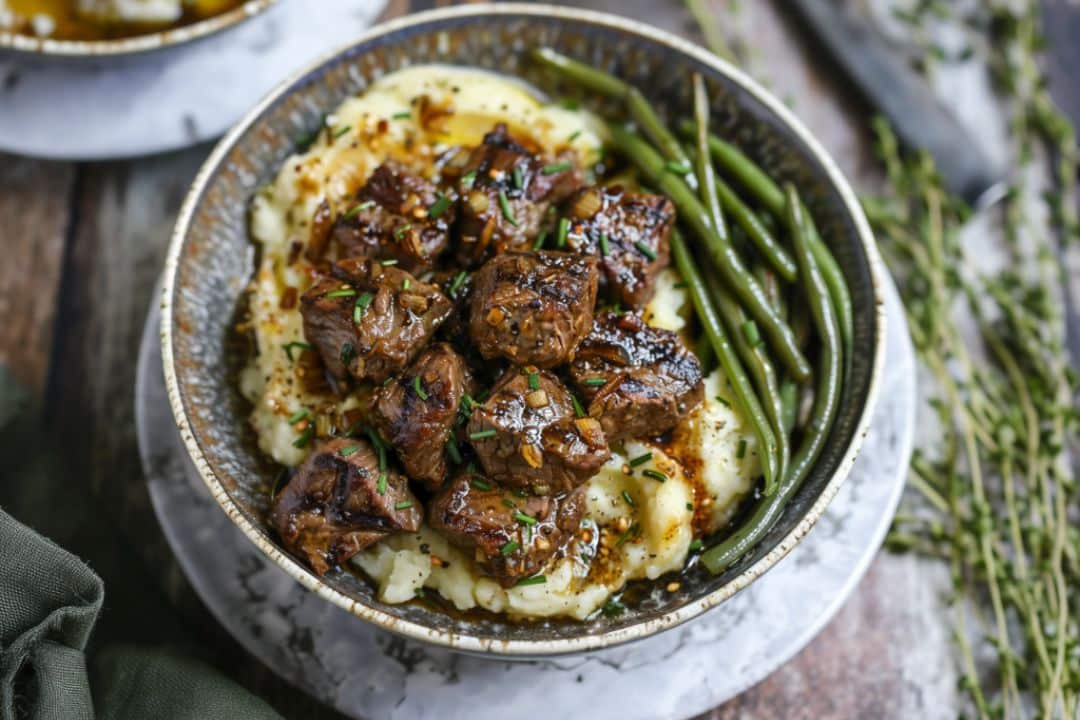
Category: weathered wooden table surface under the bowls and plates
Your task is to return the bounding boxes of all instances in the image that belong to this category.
[0,0,972,719]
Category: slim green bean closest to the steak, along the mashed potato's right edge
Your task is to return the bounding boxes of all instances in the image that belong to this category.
[671,230,779,488]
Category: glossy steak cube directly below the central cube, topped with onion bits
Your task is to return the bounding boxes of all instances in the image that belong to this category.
[468,367,611,495]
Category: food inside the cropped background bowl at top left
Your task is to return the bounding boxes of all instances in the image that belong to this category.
[0,0,244,40]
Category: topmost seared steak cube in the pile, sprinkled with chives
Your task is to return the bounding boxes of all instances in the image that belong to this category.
[457,123,582,267]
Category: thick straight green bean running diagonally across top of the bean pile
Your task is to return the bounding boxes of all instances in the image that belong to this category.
[608,124,810,381]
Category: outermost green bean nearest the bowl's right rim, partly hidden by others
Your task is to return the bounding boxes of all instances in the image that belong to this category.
[679,120,854,367]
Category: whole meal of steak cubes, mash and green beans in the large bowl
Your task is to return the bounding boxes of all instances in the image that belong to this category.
[240,52,850,620]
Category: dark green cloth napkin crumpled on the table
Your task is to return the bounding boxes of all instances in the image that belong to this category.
[0,510,281,720]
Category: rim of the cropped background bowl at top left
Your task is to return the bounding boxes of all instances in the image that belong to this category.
[0,0,278,58]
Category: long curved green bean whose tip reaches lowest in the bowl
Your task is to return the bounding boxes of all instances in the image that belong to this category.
[701,186,843,574]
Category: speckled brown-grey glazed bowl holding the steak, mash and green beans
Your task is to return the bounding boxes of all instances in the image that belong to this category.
[161,4,885,656]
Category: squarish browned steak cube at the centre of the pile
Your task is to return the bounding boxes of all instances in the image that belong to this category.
[469,250,598,367]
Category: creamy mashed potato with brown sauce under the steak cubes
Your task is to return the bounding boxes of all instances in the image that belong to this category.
[241,66,759,619]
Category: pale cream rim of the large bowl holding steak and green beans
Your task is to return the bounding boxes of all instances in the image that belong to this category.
[161,2,886,657]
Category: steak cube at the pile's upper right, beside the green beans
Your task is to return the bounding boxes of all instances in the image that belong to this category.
[567,186,675,308]
